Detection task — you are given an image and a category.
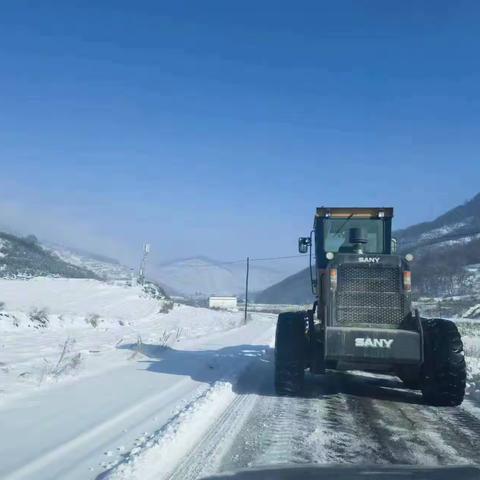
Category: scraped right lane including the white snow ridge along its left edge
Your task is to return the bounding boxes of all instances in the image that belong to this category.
[105,349,480,480]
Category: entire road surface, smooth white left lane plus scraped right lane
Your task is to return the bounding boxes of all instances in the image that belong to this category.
[5,314,480,480]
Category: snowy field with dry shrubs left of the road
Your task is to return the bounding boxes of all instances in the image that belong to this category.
[0,278,253,402]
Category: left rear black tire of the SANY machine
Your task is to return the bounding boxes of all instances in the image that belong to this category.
[275,312,308,395]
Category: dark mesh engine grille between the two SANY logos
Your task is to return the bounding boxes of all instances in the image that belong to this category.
[336,264,406,327]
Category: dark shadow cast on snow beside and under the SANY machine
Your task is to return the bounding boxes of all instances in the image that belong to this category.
[117,343,423,404]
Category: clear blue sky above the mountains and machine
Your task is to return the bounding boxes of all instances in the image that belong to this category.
[0,0,480,261]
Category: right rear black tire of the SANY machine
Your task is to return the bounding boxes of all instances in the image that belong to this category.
[421,318,467,406]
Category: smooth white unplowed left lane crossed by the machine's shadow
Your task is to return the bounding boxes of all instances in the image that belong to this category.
[0,315,273,479]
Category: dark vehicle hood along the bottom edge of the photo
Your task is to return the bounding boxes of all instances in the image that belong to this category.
[204,465,480,480]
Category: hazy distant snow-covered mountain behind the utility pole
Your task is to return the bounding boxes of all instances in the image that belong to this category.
[150,256,304,296]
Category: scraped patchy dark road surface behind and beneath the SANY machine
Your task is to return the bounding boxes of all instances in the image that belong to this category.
[217,372,480,470]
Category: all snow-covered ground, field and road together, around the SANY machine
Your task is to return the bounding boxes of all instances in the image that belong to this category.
[0,278,480,480]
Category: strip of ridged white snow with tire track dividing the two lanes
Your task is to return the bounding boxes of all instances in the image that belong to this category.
[98,330,272,479]
